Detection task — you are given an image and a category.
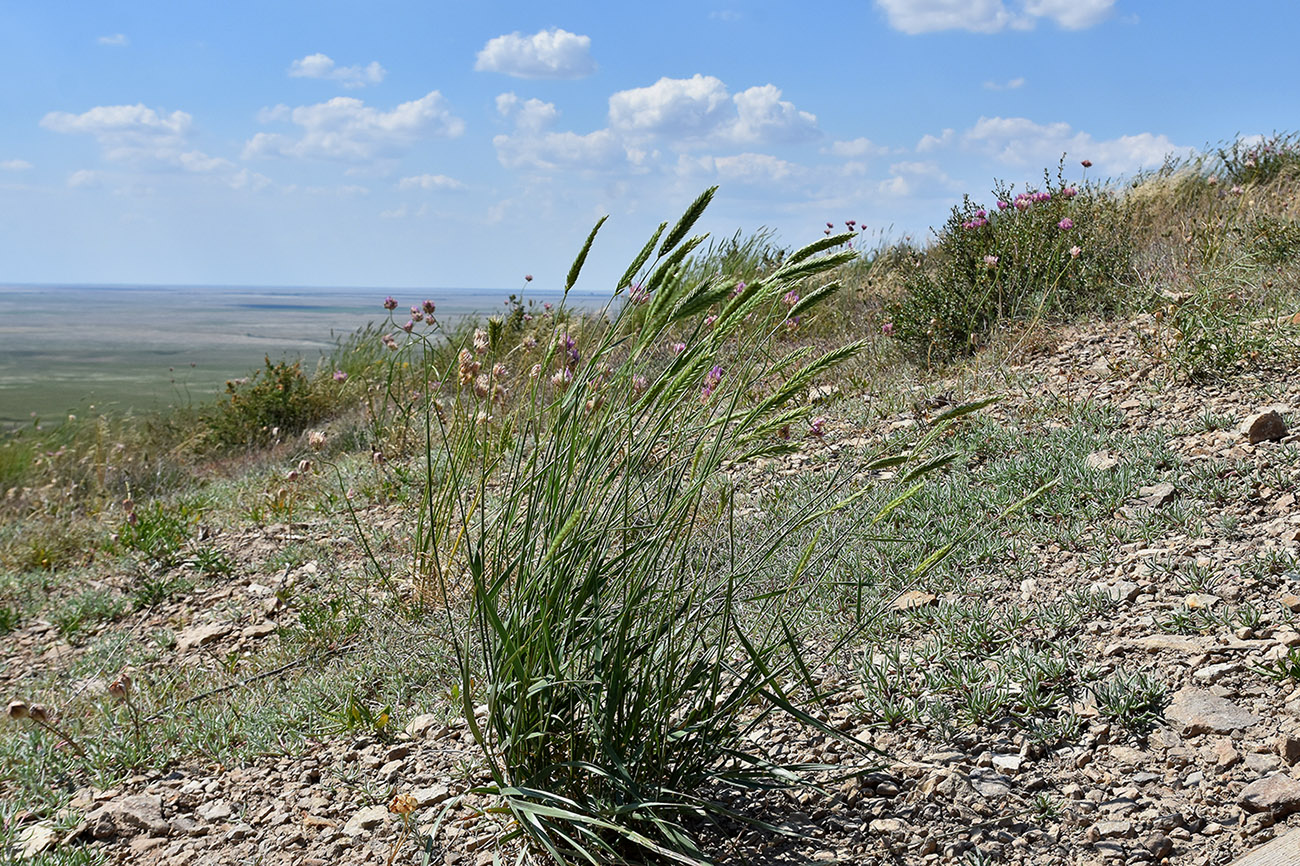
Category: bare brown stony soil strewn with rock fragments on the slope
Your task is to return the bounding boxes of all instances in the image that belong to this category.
[4,312,1300,866]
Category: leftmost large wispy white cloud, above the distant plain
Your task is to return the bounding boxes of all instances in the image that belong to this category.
[40,104,234,173]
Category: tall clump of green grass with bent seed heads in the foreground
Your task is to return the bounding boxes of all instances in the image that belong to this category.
[377,190,967,863]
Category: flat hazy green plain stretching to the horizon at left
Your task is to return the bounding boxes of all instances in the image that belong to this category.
[0,285,594,426]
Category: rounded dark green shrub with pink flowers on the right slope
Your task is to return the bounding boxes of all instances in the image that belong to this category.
[889,163,1132,361]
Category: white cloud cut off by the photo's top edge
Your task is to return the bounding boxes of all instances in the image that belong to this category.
[876,0,1115,35]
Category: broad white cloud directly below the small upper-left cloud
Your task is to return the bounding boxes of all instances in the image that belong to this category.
[243,90,465,163]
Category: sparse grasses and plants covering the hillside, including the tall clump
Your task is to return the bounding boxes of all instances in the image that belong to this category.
[0,135,1300,865]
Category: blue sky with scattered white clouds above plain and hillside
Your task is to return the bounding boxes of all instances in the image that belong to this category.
[0,0,1300,290]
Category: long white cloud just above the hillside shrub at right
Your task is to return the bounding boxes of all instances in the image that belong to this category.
[962,117,1193,174]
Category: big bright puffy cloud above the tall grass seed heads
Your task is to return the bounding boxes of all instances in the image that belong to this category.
[610,73,822,146]
